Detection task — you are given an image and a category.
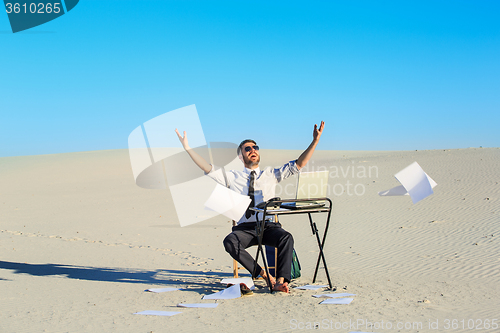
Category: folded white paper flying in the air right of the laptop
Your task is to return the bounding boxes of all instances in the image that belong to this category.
[378,162,437,204]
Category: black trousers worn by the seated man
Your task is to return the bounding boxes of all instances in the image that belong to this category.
[224,222,293,282]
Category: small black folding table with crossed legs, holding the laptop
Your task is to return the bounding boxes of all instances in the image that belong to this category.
[250,198,333,292]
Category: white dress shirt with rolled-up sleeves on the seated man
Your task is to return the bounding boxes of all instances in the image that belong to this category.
[207,161,299,224]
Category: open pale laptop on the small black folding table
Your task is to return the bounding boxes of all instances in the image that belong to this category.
[281,170,329,209]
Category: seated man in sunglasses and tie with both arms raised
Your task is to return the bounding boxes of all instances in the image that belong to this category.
[175,121,325,293]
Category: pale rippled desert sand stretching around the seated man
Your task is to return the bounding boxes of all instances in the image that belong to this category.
[0,148,500,333]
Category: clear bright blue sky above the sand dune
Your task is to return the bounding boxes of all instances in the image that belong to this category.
[0,0,500,156]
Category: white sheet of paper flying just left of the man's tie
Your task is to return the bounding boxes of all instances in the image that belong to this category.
[205,184,251,221]
